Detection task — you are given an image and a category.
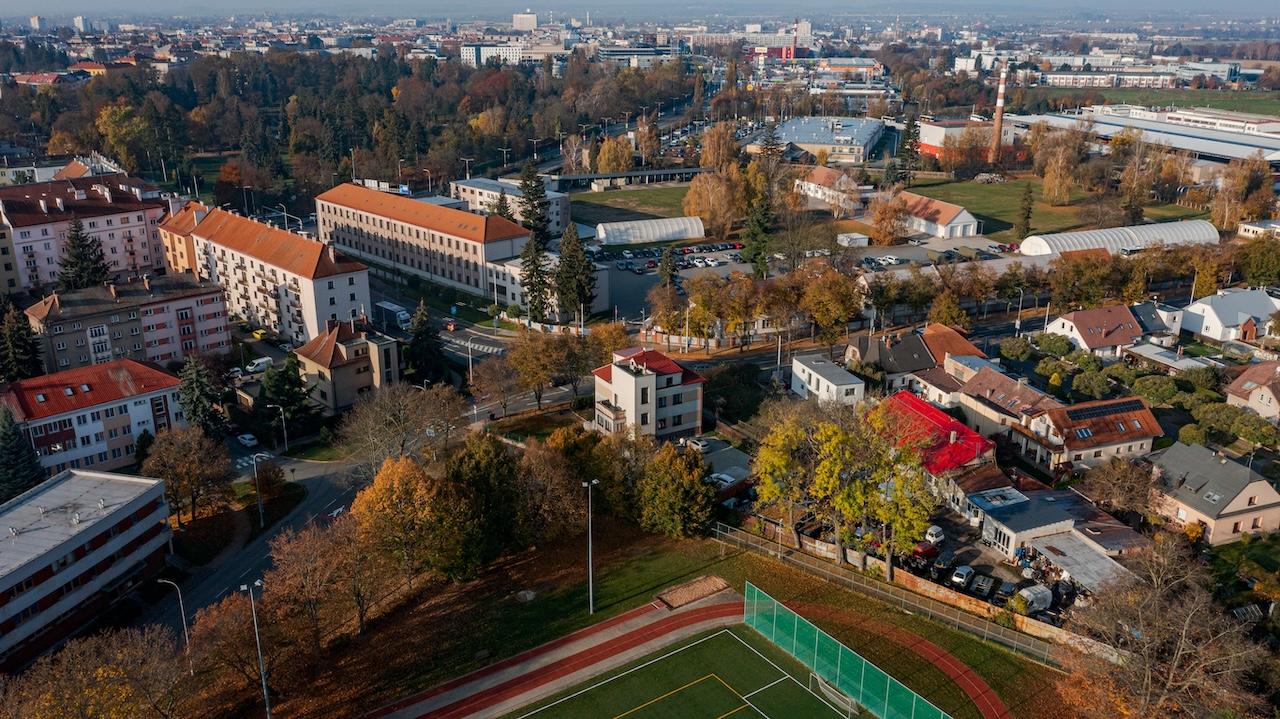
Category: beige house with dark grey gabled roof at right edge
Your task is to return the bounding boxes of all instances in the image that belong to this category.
[1151,441,1280,546]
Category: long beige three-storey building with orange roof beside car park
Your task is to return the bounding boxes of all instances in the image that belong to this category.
[316,183,529,297]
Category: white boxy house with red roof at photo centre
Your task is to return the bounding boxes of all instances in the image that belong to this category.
[591,347,707,440]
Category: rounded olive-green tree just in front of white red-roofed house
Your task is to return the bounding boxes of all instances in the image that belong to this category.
[636,444,716,537]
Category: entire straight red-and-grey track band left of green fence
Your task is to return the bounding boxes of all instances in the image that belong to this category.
[367,591,742,719]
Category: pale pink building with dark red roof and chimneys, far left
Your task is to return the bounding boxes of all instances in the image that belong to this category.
[0,174,166,292]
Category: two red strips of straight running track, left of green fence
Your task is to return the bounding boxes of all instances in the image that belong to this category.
[369,601,742,719]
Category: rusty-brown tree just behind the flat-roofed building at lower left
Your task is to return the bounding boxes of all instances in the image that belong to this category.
[142,426,236,526]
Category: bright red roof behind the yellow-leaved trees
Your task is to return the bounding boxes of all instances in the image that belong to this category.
[877,390,996,475]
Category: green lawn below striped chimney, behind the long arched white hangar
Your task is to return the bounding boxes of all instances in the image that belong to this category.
[911,178,1204,242]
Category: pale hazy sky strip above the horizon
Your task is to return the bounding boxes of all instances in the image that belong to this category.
[0,0,1280,22]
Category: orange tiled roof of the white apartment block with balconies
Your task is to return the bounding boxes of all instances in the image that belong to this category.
[192,210,367,279]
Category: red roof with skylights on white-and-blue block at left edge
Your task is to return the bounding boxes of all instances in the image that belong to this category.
[4,360,179,421]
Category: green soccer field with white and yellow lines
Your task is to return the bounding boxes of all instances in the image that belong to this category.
[508,624,869,719]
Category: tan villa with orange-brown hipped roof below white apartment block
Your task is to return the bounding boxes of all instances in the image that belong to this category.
[293,321,402,416]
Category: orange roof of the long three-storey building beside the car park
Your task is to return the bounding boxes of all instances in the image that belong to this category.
[316,183,529,242]
